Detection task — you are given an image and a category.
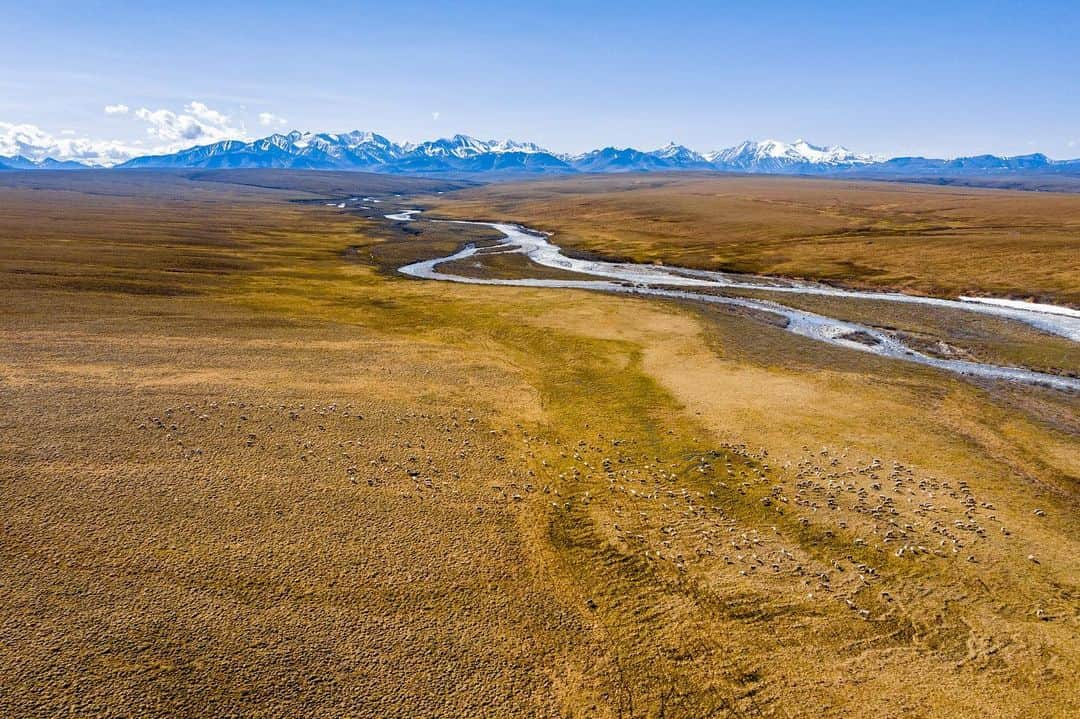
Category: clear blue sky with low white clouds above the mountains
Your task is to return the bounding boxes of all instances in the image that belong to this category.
[0,0,1080,164]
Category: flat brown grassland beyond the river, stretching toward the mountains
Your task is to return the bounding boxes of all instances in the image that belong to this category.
[432,174,1080,307]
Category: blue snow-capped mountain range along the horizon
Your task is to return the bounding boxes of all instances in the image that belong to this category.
[0,131,1080,177]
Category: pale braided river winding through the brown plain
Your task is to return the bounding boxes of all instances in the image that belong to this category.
[387,211,1080,392]
